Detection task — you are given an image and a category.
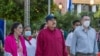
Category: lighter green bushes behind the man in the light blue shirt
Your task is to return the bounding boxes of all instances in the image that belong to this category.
[55,12,100,31]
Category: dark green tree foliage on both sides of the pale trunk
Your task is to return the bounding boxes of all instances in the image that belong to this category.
[0,0,53,30]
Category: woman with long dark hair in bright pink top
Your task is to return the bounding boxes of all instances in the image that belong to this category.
[4,22,27,56]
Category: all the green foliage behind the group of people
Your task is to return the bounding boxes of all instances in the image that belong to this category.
[0,0,100,32]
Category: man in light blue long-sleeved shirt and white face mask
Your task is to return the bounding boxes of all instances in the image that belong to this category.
[71,15,98,56]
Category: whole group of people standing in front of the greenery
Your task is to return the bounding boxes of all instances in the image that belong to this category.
[0,14,100,56]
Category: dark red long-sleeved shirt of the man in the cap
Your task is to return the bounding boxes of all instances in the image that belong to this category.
[35,28,68,56]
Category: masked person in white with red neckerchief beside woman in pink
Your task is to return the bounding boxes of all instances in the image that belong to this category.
[24,26,36,56]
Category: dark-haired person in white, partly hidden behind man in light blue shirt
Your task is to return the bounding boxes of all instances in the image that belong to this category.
[65,20,80,55]
